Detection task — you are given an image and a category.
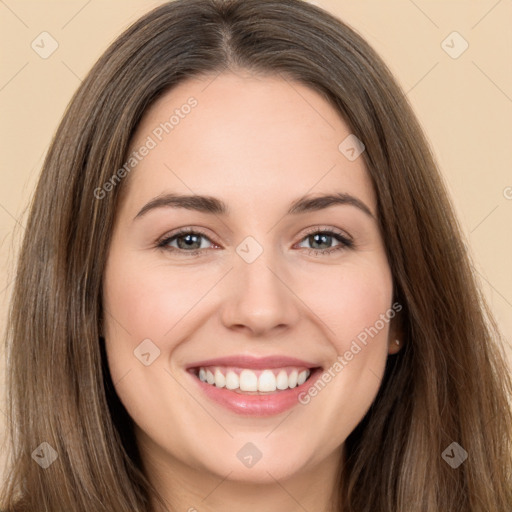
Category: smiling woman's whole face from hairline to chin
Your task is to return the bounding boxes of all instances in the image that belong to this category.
[103,74,396,488]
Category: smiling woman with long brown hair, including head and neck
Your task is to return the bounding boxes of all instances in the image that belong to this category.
[2,0,512,512]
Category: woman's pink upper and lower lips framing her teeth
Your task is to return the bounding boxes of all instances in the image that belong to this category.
[187,356,323,416]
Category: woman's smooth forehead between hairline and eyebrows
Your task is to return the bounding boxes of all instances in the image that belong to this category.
[120,69,375,213]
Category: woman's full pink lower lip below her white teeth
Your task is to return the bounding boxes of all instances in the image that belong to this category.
[190,368,322,416]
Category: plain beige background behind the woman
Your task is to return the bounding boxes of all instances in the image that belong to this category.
[0,0,512,480]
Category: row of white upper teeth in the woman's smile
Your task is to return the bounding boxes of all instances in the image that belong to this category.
[198,368,311,393]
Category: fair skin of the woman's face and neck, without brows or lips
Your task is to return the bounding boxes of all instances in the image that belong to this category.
[103,72,398,512]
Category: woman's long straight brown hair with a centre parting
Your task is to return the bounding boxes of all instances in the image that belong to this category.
[0,0,512,512]
